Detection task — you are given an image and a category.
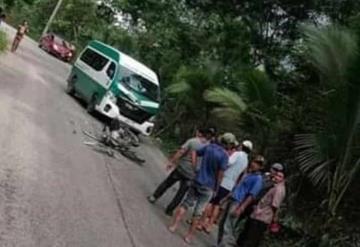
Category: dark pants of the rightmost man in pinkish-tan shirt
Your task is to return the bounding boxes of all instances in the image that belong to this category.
[238,218,268,247]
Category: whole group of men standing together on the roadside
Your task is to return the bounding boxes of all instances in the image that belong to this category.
[148,128,285,247]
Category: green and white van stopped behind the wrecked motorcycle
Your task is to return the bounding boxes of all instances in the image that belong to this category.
[67,41,160,135]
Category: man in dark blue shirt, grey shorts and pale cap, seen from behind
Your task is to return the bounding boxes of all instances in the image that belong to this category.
[169,133,232,243]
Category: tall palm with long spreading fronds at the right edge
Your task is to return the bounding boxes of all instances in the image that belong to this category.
[296,26,360,215]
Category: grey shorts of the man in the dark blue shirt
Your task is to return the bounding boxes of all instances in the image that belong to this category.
[181,183,213,217]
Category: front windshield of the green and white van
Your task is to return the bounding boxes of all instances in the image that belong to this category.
[120,67,160,102]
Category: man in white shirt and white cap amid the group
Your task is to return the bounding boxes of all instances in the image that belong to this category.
[198,140,253,233]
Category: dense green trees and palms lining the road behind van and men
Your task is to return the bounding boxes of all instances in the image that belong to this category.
[0,0,360,247]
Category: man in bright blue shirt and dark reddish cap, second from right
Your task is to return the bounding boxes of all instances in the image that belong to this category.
[218,155,265,247]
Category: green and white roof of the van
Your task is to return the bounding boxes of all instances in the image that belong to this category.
[89,40,159,85]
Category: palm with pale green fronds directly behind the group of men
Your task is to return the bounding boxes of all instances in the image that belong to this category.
[205,69,279,153]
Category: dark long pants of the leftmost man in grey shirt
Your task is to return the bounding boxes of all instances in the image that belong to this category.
[153,169,192,213]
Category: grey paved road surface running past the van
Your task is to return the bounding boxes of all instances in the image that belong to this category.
[0,26,212,247]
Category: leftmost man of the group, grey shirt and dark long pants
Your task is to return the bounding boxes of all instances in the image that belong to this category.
[148,129,214,216]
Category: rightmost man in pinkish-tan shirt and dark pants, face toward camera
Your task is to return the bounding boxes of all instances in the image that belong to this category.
[240,171,286,247]
